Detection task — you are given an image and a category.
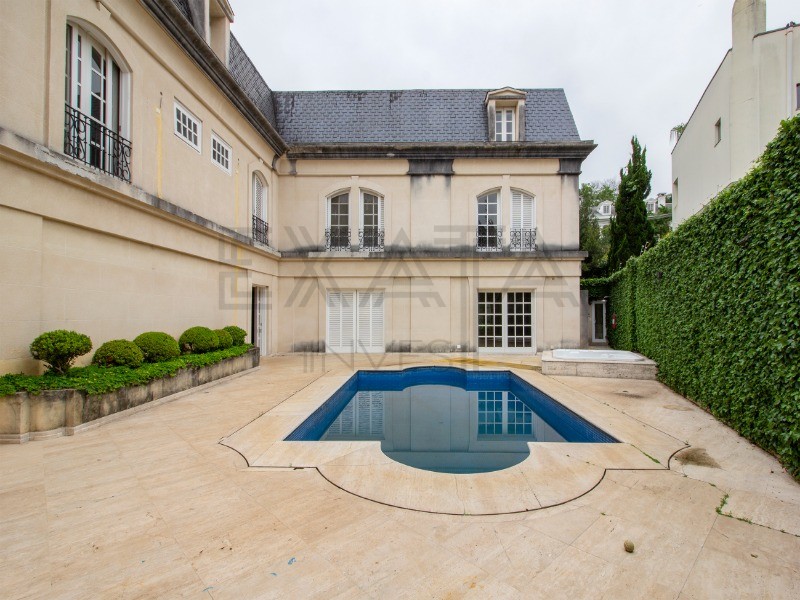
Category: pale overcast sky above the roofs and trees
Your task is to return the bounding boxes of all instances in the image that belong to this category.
[231,0,800,194]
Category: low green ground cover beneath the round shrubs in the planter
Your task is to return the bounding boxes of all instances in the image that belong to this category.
[0,344,252,396]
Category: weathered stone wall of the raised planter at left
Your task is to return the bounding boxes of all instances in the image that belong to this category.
[0,348,260,444]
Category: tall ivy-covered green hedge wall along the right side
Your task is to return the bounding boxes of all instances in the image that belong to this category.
[609,117,800,477]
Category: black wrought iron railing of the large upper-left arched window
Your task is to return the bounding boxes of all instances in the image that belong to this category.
[64,104,131,181]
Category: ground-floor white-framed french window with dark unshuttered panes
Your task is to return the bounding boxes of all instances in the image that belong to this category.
[478,292,534,349]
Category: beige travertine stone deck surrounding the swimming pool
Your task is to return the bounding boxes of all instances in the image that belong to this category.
[0,355,800,598]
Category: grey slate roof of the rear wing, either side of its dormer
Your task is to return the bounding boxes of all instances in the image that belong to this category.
[273,89,580,145]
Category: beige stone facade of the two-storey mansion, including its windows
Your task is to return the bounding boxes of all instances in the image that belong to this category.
[0,0,594,373]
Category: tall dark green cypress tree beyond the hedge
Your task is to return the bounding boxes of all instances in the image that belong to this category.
[608,136,655,273]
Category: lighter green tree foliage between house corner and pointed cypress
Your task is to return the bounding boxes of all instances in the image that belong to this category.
[578,179,617,277]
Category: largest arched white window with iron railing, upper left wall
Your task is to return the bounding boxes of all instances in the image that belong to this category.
[64,23,131,181]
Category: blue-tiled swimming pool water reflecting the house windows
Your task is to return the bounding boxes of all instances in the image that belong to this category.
[286,367,617,473]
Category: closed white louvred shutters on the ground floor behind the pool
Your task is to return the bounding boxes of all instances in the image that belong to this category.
[327,290,385,353]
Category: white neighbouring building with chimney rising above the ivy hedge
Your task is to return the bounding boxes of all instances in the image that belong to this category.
[672,0,800,228]
